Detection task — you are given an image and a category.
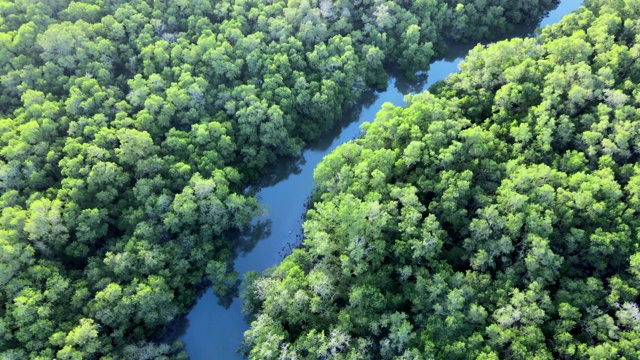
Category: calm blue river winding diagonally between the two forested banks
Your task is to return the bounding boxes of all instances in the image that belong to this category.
[180,0,582,360]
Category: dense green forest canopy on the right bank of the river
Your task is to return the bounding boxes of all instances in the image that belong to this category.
[244,0,640,359]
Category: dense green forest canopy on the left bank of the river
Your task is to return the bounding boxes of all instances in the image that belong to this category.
[0,0,553,359]
